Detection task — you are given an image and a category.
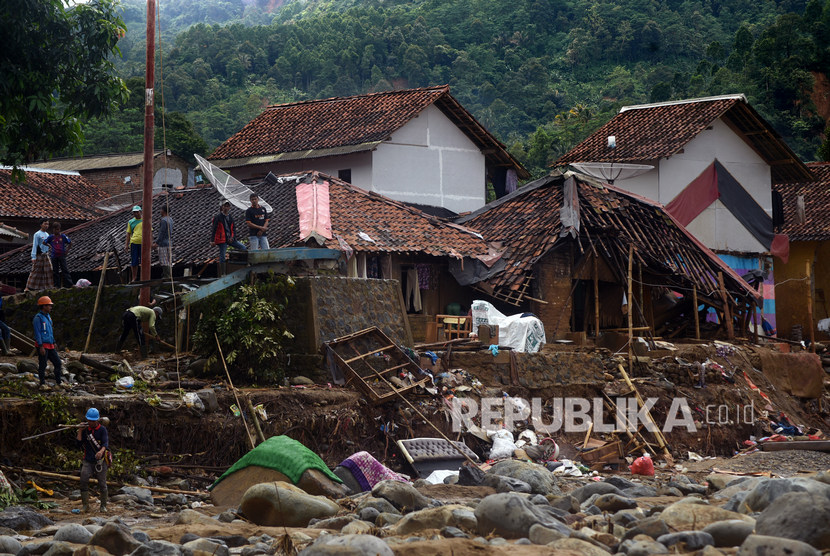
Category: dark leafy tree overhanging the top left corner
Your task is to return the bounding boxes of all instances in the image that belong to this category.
[0,0,127,176]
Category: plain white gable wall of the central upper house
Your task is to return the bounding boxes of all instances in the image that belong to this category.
[372,106,485,212]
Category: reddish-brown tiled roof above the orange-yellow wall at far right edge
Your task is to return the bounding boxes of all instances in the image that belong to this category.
[775,162,830,241]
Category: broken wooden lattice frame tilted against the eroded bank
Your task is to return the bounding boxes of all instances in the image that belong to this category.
[325,326,430,404]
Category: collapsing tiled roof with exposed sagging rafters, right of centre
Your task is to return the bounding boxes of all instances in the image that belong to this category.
[456,172,757,302]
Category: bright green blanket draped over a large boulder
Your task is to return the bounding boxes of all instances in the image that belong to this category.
[208,436,343,490]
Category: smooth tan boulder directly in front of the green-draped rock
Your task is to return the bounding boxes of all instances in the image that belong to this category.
[239,481,340,527]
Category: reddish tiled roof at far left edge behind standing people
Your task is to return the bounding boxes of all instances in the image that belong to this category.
[0,168,107,220]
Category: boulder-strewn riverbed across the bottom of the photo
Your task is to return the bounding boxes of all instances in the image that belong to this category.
[0,454,830,556]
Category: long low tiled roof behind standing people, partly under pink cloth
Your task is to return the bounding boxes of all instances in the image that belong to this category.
[0,172,488,275]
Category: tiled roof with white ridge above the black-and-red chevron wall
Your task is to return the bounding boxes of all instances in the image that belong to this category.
[553,95,809,182]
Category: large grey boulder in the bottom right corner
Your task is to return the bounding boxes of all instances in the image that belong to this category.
[755,490,830,550]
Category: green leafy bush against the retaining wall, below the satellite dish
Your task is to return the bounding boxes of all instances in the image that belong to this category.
[193,276,294,385]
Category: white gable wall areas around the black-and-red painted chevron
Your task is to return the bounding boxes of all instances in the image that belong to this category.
[615,120,772,253]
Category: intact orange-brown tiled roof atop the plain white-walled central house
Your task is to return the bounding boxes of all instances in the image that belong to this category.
[208,85,530,178]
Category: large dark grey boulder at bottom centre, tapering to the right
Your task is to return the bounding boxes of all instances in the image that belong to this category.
[475,493,571,539]
